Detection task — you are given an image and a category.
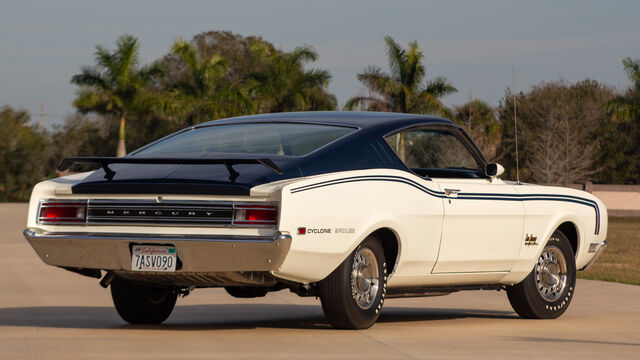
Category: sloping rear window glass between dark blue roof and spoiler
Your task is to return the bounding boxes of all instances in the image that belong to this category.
[136,123,355,156]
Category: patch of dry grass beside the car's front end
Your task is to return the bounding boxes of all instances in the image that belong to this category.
[578,218,640,285]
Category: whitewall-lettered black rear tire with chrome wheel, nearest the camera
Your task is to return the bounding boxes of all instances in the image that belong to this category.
[318,235,387,329]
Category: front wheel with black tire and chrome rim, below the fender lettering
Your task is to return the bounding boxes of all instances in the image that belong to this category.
[507,230,576,319]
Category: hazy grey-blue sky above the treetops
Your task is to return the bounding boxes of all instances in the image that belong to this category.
[0,0,640,127]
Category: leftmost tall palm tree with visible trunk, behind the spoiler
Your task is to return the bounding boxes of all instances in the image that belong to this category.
[71,35,160,156]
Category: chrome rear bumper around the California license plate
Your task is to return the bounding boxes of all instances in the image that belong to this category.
[23,229,291,274]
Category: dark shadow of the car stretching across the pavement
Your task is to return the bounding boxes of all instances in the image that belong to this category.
[0,304,517,331]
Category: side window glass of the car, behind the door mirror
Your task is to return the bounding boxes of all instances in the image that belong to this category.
[385,129,480,178]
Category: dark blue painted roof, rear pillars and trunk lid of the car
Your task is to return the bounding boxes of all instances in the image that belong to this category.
[72,111,480,195]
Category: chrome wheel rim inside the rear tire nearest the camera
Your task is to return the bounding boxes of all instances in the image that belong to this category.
[351,247,380,310]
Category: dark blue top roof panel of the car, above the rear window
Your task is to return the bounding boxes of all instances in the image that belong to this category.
[196,111,455,129]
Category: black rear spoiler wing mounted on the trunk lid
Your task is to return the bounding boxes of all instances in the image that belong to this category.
[58,156,282,182]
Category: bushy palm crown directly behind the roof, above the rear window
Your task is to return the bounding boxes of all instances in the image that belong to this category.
[252,42,336,112]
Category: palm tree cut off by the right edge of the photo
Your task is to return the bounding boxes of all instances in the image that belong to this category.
[607,57,640,121]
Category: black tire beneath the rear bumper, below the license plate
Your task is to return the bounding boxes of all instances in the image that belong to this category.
[111,276,178,324]
